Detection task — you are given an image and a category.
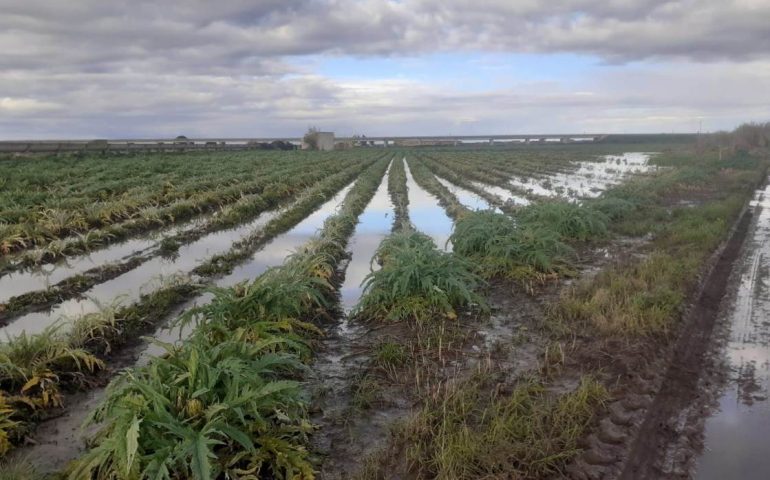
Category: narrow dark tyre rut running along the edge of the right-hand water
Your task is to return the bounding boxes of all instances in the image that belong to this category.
[616,209,753,480]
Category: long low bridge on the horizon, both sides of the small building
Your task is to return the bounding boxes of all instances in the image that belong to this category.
[0,133,607,153]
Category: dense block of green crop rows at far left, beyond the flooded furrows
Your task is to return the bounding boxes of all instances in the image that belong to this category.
[0,152,376,254]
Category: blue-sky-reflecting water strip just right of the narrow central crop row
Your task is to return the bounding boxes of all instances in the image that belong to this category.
[405,162,452,251]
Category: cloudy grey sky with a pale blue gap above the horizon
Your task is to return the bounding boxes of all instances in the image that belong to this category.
[0,0,770,139]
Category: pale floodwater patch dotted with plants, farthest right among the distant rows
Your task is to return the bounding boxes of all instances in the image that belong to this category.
[510,152,655,200]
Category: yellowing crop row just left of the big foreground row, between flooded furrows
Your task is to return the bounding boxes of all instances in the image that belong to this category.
[0,156,382,460]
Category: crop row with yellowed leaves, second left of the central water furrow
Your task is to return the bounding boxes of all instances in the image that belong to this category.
[0,160,384,462]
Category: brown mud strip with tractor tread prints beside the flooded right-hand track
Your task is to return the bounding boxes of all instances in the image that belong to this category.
[556,203,752,479]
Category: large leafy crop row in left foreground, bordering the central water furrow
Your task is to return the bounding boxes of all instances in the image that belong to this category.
[14,159,388,479]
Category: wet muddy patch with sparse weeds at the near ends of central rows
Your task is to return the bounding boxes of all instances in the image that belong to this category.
[309,234,646,480]
